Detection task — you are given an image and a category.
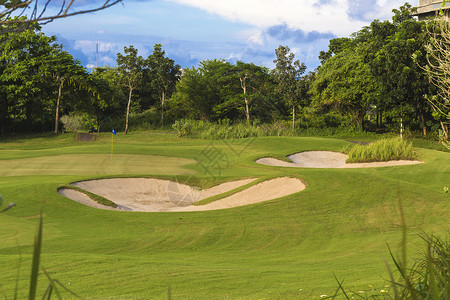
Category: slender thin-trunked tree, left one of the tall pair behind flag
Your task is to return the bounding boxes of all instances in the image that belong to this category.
[117,46,144,134]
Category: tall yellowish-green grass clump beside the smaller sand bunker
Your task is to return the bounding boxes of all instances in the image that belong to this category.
[346,138,417,163]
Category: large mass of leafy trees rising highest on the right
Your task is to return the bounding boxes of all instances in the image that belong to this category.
[310,4,433,135]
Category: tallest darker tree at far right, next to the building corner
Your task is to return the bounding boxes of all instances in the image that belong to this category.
[368,4,433,135]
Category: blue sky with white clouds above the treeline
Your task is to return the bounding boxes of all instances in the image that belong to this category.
[38,0,417,71]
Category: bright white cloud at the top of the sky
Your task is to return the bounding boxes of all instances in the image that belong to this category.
[167,0,410,37]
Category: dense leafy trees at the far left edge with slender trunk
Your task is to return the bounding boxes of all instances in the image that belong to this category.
[0,24,88,135]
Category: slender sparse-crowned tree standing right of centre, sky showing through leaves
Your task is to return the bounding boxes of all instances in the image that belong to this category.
[273,45,306,129]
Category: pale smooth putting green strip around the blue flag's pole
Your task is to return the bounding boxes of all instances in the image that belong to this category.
[0,154,195,176]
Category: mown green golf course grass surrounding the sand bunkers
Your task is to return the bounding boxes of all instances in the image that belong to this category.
[0,132,450,299]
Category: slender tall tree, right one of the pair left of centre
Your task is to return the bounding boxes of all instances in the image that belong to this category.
[146,44,181,125]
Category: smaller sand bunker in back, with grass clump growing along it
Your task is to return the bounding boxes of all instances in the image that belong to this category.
[256,151,421,168]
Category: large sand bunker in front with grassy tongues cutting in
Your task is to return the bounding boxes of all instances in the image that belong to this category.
[58,177,305,212]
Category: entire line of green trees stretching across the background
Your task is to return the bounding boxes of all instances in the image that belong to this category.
[0,4,442,136]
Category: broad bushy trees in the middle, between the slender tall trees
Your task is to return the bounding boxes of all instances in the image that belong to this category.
[170,59,273,123]
